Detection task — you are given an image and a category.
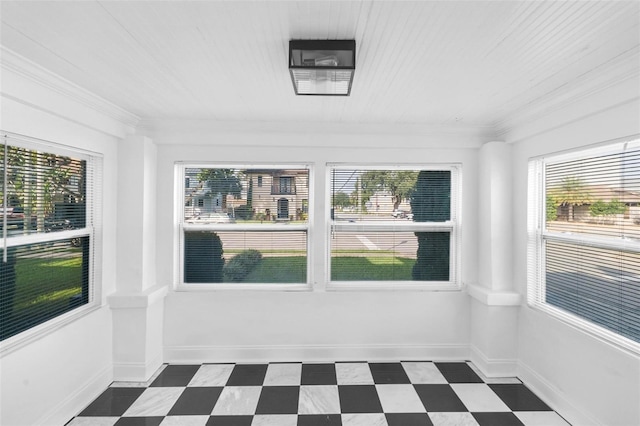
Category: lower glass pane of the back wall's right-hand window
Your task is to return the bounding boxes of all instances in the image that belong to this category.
[331,232,451,281]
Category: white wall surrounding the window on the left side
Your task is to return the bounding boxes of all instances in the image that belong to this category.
[0,51,126,426]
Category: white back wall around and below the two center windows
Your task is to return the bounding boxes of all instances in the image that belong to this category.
[154,130,479,362]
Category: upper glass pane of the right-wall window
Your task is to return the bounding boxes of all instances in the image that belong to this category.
[545,149,640,241]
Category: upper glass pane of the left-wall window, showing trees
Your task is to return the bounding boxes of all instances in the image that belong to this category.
[0,145,87,237]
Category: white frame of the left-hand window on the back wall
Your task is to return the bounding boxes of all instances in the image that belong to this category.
[173,161,314,292]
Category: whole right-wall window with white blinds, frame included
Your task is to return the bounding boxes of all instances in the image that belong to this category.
[528,139,640,350]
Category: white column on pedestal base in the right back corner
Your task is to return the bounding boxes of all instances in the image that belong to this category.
[468,142,521,377]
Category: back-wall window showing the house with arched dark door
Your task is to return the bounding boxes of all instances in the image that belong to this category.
[177,164,310,289]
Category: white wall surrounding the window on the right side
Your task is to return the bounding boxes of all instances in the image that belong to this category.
[507,78,640,426]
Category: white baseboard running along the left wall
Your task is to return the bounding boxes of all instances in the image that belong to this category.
[34,366,113,426]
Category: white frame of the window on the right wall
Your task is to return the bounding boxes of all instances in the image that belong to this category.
[527,135,640,354]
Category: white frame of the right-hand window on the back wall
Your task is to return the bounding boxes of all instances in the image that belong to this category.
[325,162,462,291]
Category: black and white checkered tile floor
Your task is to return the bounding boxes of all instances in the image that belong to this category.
[67,362,568,426]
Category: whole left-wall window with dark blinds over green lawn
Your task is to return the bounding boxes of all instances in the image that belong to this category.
[0,135,100,344]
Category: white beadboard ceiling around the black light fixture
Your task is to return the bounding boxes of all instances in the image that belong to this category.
[0,0,640,133]
